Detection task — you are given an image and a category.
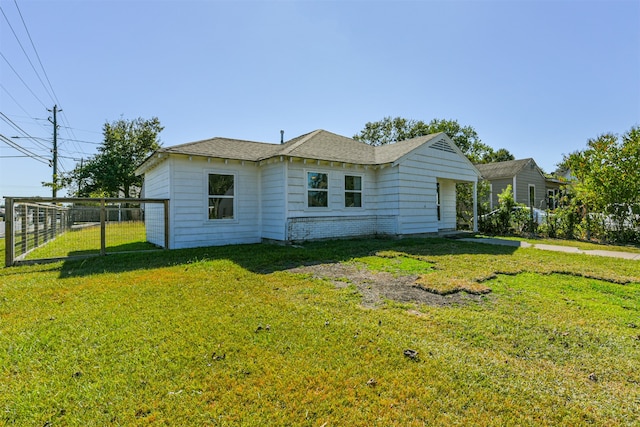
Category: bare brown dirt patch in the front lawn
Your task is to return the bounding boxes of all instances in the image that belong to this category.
[289,263,486,308]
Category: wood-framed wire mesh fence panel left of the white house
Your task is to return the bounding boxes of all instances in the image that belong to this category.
[5,197,169,267]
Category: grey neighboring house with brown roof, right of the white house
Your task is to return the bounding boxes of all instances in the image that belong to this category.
[475,158,561,209]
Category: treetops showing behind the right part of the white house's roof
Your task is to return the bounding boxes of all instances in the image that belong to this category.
[353,117,513,163]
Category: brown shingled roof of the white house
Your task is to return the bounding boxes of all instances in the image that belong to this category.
[136,129,470,174]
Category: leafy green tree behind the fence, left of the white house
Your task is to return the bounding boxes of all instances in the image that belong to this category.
[64,117,164,197]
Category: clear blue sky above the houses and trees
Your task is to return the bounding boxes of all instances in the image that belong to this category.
[0,0,640,197]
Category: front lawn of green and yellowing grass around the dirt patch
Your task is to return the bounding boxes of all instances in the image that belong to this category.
[0,239,640,426]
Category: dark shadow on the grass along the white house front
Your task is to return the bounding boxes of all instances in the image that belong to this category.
[60,238,517,278]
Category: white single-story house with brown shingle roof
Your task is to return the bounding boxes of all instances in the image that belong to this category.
[136,130,479,249]
